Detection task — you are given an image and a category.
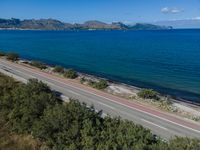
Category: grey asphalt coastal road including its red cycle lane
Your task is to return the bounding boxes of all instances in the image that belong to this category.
[0,59,200,140]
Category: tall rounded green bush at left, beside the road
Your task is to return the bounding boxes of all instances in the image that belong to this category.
[9,79,57,133]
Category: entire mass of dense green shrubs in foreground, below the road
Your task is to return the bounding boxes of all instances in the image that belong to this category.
[0,74,200,150]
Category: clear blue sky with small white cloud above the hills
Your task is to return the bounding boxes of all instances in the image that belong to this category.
[0,0,200,23]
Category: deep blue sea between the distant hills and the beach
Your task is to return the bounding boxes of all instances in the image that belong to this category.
[0,30,200,102]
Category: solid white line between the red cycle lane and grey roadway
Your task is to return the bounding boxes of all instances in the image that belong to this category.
[1,59,200,133]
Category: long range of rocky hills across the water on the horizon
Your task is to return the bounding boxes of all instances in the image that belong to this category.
[0,18,172,30]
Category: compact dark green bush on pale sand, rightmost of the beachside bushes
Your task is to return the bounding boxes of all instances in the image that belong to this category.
[137,89,159,100]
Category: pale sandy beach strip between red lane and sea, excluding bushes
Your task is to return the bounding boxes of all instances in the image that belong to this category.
[13,58,200,123]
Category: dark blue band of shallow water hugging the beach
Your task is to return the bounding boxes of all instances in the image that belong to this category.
[14,52,200,106]
